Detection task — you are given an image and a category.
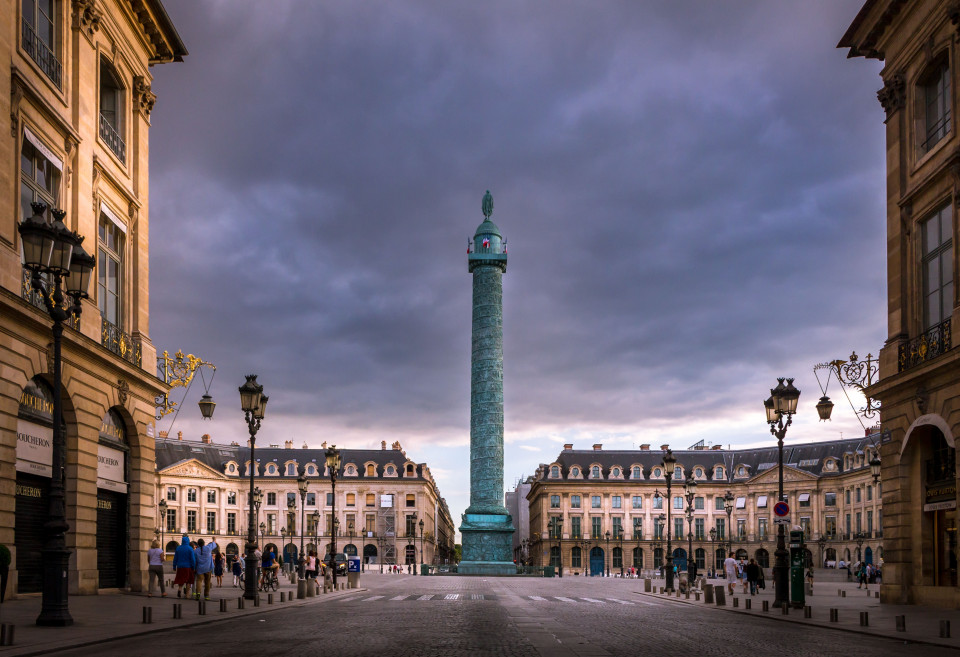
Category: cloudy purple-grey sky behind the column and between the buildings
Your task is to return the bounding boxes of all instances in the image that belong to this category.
[150,0,886,524]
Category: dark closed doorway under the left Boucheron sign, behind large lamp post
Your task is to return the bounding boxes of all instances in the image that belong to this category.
[14,472,50,593]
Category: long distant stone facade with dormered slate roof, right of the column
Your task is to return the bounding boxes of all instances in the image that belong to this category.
[527,434,885,575]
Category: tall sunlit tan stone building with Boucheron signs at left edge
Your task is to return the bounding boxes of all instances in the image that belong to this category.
[0,0,187,594]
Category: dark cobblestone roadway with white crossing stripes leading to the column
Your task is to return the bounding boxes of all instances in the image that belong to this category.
[48,574,957,657]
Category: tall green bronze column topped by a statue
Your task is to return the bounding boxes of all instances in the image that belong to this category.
[458,190,516,575]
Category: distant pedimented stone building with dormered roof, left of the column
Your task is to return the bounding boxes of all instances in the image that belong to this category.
[156,435,454,565]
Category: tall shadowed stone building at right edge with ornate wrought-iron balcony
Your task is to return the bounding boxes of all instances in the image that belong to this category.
[839,0,960,607]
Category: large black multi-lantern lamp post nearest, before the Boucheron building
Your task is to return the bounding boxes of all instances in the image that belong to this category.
[17,203,96,627]
